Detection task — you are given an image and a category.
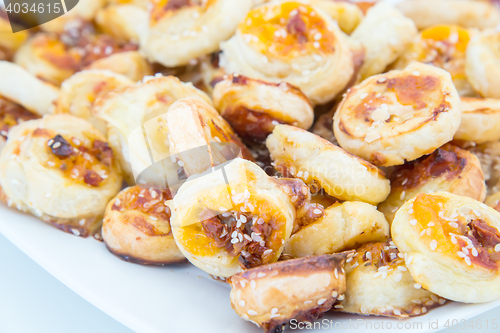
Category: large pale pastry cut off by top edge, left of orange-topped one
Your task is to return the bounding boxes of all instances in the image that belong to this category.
[140,0,253,67]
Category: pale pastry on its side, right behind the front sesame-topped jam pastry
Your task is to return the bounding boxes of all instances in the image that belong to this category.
[166,98,253,177]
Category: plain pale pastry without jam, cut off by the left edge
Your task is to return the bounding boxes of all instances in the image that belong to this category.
[0,61,59,116]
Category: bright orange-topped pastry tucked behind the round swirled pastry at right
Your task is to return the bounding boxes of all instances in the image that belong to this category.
[395,25,475,96]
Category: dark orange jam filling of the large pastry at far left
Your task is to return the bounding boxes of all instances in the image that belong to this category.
[45,133,113,187]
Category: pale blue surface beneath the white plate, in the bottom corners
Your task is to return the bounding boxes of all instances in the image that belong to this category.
[0,234,500,333]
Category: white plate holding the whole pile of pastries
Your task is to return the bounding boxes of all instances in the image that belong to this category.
[0,205,500,333]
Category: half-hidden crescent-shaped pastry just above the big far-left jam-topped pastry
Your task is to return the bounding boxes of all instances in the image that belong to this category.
[55,70,134,133]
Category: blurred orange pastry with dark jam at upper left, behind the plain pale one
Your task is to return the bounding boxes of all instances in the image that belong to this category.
[14,20,141,85]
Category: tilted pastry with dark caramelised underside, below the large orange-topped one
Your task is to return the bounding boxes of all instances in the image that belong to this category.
[213,74,314,141]
